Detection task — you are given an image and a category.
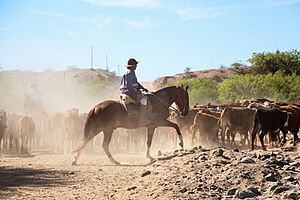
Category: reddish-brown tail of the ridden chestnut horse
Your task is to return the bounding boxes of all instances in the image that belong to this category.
[72,109,95,153]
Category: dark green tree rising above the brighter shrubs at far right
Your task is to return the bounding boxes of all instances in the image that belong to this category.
[248,49,300,75]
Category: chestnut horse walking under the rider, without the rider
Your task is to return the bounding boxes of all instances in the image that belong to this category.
[72,86,189,165]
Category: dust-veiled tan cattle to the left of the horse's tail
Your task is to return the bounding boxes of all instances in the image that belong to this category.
[0,108,85,154]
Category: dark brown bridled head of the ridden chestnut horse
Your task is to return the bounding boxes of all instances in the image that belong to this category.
[175,85,189,116]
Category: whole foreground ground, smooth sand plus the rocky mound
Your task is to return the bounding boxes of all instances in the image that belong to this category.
[0,147,300,199]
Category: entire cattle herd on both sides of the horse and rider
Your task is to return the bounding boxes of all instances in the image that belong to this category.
[0,99,300,154]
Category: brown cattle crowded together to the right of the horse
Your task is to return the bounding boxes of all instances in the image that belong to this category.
[174,99,300,150]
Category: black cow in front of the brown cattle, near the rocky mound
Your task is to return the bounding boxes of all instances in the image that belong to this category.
[252,108,289,150]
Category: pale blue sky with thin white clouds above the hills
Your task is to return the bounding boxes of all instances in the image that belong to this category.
[0,0,300,81]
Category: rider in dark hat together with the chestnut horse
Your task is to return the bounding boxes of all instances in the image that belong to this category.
[72,58,189,165]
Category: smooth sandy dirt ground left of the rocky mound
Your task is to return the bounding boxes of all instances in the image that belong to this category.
[0,152,152,199]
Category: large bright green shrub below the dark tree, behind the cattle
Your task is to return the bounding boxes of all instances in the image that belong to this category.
[218,70,300,103]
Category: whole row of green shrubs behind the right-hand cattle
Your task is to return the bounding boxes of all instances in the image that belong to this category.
[174,70,300,104]
